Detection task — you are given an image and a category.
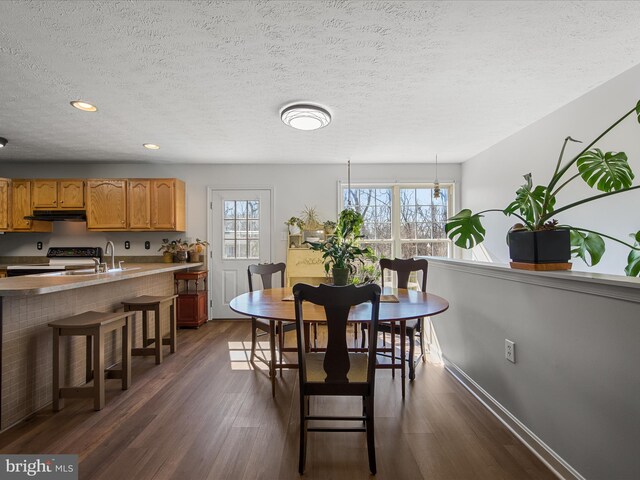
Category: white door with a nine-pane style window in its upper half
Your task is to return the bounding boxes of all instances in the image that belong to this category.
[209,188,271,318]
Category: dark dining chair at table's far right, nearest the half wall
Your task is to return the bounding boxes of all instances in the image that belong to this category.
[361,258,429,380]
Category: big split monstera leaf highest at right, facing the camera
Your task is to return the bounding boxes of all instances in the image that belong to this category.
[576,148,634,192]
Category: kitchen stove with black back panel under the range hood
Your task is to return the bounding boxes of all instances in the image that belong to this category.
[7,247,102,277]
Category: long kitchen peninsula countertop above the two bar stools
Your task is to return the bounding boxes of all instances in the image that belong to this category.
[0,263,203,297]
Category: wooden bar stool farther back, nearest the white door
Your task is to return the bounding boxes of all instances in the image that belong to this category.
[122,295,178,365]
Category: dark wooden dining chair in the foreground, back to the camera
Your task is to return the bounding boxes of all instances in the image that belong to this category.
[293,283,380,475]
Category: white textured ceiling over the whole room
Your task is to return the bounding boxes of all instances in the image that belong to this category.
[0,0,640,163]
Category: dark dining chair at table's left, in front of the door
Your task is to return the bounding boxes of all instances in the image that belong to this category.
[247,262,296,397]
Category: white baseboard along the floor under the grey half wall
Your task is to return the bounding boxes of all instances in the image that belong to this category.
[443,356,585,480]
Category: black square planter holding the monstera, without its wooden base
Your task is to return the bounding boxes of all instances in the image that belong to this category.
[509,229,571,263]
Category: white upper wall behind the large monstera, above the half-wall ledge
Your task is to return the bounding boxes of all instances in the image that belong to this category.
[461,65,640,275]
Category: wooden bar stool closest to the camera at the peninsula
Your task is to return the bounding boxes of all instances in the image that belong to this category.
[49,311,132,412]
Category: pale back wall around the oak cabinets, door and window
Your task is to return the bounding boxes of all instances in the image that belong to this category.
[0,163,460,261]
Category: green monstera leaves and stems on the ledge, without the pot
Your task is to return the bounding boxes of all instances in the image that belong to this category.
[445,101,640,276]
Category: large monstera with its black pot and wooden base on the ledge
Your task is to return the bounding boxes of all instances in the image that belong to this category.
[445,101,640,276]
